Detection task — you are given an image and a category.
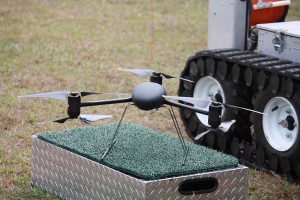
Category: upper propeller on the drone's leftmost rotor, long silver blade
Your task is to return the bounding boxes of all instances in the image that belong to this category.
[18,91,126,101]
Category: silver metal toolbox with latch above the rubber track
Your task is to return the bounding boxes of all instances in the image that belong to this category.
[257,21,300,63]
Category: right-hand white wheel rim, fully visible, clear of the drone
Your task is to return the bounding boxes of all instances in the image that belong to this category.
[263,97,299,151]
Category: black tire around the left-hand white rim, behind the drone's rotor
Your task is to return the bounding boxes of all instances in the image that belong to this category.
[178,57,252,153]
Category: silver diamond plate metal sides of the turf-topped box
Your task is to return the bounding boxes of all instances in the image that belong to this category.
[30,136,248,200]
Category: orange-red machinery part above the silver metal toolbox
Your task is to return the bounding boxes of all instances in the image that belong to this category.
[250,0,288,26]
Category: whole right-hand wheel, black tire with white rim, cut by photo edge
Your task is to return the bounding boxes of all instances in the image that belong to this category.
[254,89,300,178]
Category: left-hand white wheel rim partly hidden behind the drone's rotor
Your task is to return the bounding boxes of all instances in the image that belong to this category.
[193,76,226,126]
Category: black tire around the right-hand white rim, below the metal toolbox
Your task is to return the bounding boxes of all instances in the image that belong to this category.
[253,84,300,179]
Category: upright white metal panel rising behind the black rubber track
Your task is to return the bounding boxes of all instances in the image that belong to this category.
[208,0,247,49]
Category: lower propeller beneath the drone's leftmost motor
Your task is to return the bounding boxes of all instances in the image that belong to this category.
[36,114,112,125]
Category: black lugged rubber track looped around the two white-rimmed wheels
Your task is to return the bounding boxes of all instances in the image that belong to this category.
[178,49,300,181]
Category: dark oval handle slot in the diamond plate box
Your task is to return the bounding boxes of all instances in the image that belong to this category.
[178,177,219,195]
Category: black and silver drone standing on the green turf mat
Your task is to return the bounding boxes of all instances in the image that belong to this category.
[19,69,264,166]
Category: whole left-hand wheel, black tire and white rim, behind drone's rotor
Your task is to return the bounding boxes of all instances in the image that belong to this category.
[178,58,251,153]
